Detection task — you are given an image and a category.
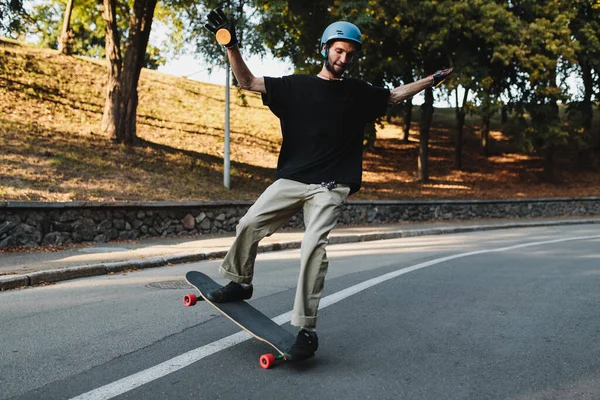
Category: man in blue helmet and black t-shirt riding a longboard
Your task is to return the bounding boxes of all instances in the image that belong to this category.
[205,8,452,360]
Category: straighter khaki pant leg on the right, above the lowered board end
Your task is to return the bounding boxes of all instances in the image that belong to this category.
[291,185,350,327]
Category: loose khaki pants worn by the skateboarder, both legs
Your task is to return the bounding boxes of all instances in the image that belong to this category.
[219,179,350,327]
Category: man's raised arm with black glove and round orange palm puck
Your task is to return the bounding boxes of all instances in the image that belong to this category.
[204,7,266,93]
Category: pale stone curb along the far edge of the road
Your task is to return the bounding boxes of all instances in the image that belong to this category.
[0,218,600,291]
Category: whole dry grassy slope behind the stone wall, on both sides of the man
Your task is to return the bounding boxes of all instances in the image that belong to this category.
[0,39,600,201]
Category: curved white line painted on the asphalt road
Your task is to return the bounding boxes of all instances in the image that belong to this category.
[73,235,600,400]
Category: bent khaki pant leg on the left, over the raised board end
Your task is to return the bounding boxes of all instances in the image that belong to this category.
[219,179,307,283]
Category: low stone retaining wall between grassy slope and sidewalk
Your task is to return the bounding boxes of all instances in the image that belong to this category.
[0,197,600,247]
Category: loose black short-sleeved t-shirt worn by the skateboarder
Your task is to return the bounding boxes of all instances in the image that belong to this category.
[262,75,390,193]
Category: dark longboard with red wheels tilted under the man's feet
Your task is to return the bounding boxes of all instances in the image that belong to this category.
[183,271,296,369]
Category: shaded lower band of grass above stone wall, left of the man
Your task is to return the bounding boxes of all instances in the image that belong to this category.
[0,121,274,200]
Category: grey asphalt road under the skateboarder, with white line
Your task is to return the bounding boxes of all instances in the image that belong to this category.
[0,225,600,400]
